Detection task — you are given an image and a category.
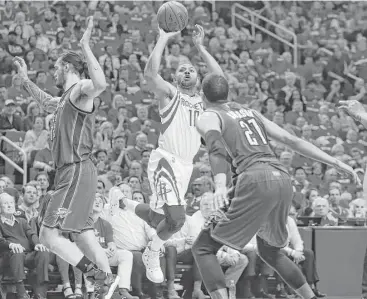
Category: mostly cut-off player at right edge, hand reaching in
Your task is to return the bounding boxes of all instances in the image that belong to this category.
[339,100,367,299]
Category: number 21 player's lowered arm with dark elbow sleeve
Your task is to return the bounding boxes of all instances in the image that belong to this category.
[196,111,229,208]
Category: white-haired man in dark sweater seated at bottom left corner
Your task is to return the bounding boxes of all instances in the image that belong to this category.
[0,193,49,299]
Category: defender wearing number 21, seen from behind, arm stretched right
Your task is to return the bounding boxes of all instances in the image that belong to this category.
[193,74,358,299]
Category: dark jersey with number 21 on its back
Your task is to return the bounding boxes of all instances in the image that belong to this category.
[206,102,286,173]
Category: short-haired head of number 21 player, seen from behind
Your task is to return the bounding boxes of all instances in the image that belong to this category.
[202,73,229,103]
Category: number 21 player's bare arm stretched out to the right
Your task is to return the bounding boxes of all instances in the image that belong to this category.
[258,114,361,185]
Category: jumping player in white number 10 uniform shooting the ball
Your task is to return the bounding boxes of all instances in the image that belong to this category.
[116,25,223,283]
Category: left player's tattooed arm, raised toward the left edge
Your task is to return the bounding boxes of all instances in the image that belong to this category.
[14,57,59,113]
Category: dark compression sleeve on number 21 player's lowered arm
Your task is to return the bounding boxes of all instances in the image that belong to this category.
[204,130,228,175]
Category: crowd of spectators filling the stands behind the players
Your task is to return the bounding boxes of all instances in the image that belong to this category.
[0,1,367,299]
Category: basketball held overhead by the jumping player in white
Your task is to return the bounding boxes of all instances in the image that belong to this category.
[157,1,189,32]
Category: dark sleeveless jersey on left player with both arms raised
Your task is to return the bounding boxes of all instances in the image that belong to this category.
[50,85,95,168]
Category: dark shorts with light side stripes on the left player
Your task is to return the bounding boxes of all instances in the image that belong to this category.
[40,160,97,233]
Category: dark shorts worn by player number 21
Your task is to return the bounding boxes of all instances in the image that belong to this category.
[211,163,293,250]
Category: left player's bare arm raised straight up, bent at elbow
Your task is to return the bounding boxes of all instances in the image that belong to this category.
[80,17,107,100]
